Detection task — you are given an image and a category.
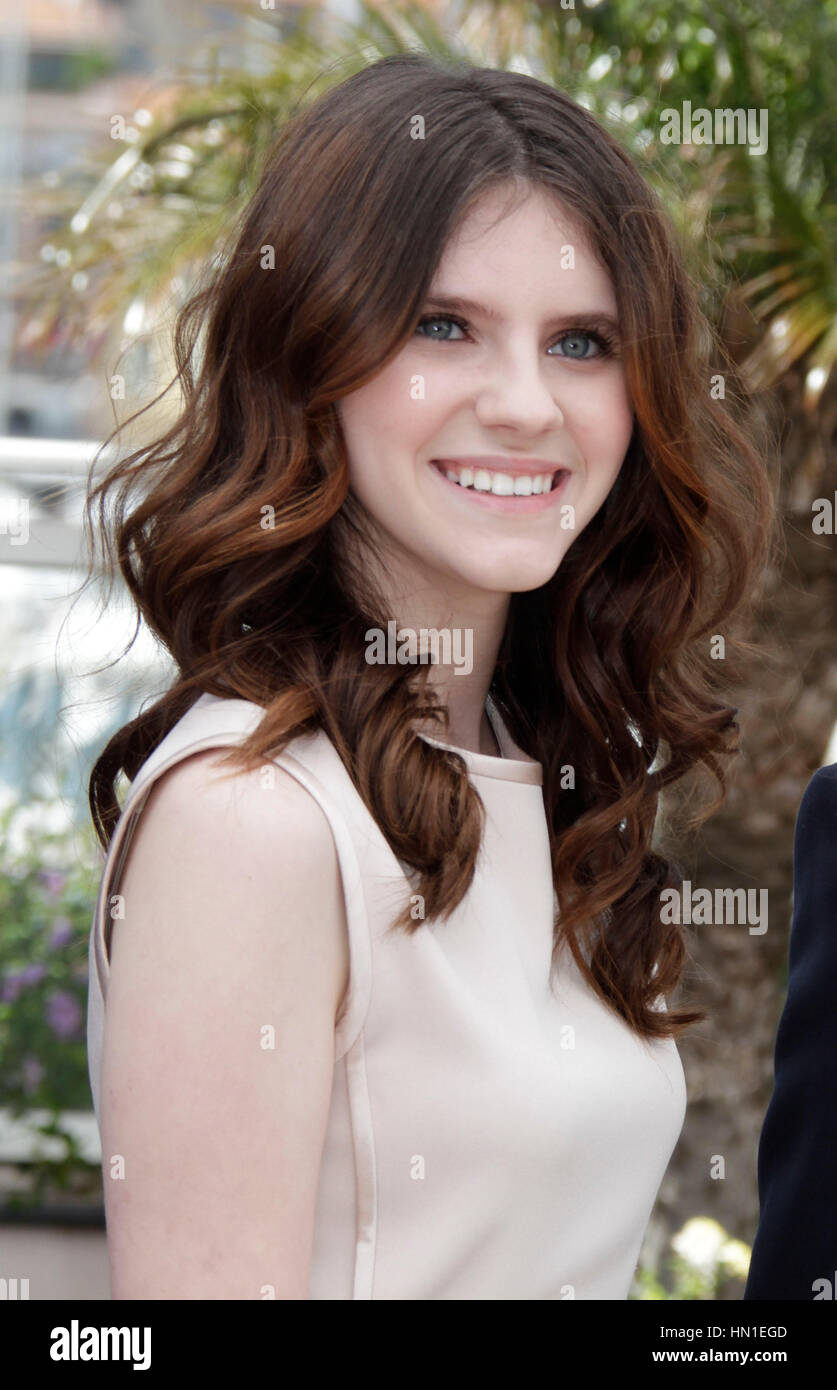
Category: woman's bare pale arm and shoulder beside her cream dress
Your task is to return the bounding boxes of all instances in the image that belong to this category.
[101,749,349,1300]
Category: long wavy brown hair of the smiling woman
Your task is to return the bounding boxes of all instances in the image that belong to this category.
[85,53,773,1038]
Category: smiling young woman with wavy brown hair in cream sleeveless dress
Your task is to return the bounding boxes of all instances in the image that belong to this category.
[83,54,770,1300]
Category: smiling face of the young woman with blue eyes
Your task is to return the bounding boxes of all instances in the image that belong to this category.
[338,179,633,594]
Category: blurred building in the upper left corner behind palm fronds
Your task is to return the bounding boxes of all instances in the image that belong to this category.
[0,0,322,439]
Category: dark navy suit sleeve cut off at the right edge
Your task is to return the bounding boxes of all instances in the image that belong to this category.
[744,763,837,1300]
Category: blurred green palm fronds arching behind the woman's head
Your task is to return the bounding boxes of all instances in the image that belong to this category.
[25,0,837,410]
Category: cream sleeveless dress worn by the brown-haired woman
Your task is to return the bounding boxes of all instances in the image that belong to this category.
[88,694,685,1300]
